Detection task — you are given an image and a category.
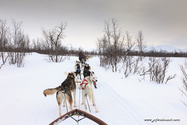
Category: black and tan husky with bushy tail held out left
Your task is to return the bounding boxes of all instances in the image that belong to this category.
[43,72,79,116]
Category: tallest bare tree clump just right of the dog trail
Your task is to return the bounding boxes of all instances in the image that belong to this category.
[97,18,124,72]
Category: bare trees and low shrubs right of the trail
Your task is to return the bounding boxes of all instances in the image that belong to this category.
[96,18,180,84]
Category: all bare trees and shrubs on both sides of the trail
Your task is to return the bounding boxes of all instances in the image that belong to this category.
[0,18,187,105]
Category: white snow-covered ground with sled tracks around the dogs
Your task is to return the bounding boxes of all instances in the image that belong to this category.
[0,53,187,125]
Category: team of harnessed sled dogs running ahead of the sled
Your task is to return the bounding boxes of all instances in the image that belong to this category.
[43,56,98,116]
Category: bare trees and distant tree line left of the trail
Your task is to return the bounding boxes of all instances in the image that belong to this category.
[0,19,96,68]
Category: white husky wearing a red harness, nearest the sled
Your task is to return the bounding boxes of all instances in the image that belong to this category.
[80,72,98,112]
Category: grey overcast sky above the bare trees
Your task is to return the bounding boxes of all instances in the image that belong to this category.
[0,0,187,50]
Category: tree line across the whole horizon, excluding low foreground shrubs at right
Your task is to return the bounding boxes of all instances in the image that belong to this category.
[0,18,187,68]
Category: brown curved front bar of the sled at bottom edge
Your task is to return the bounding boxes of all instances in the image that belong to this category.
[49,109,107,125]
